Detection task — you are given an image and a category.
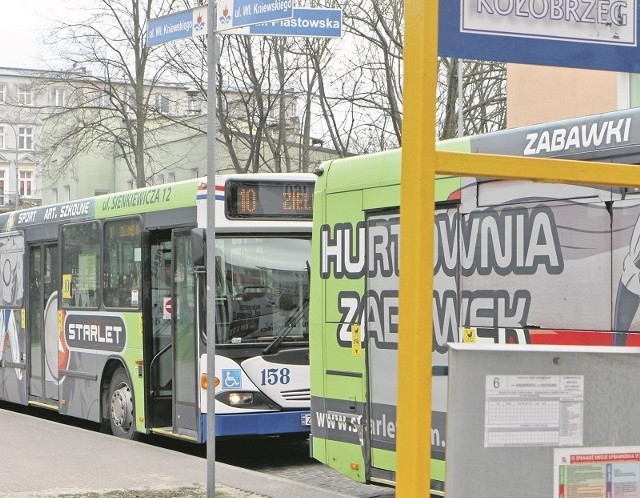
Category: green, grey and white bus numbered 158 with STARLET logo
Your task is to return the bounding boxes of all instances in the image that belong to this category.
[0,174,315,443]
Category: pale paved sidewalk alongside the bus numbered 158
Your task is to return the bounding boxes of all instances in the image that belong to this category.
[0,409,349,498]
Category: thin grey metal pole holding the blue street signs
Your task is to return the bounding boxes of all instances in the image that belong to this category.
[206,1,219,498]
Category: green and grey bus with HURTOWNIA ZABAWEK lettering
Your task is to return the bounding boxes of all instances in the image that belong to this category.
[310,109,640,494]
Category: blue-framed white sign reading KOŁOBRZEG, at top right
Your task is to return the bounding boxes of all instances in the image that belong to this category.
[438,0,640,73]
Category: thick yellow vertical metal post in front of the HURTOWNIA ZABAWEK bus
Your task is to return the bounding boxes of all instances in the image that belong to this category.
[396,0,438,497]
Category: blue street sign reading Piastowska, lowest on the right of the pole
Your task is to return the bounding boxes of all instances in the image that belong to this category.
[224,8,342,38]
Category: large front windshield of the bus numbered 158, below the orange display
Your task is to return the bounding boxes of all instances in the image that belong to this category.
[216,237,311,344]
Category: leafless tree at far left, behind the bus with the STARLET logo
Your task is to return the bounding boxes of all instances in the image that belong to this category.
[42,0,188,187]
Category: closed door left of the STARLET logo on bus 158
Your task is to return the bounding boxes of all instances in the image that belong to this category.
[27,244,59,406]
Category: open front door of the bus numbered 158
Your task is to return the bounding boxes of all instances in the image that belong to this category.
[145,230,199,439]
